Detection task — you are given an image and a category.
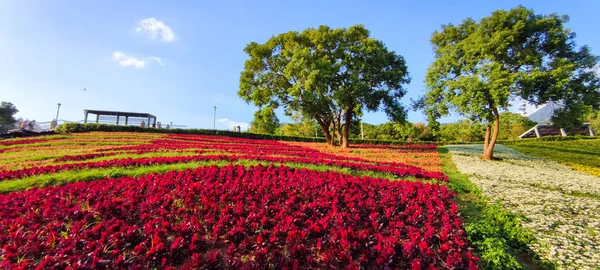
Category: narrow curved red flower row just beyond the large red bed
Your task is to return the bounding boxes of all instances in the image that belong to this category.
[0,155,448,181]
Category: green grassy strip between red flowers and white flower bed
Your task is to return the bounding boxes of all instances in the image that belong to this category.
[438,147,555,269]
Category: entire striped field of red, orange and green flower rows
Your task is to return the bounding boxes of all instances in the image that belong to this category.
[0,132,479,269]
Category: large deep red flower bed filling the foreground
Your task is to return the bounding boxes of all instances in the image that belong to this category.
[0,165,477,269]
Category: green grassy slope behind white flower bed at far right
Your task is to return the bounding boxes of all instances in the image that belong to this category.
[504,139,600,176]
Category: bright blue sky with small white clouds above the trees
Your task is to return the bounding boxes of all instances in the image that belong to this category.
[0,0,600,129]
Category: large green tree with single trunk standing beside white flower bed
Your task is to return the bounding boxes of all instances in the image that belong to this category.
[420,6,600,159]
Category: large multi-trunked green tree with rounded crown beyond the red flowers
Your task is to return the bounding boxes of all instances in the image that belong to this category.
[238,25,409,147]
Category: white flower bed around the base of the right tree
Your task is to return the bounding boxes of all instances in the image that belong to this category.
[448,145,600,269]
